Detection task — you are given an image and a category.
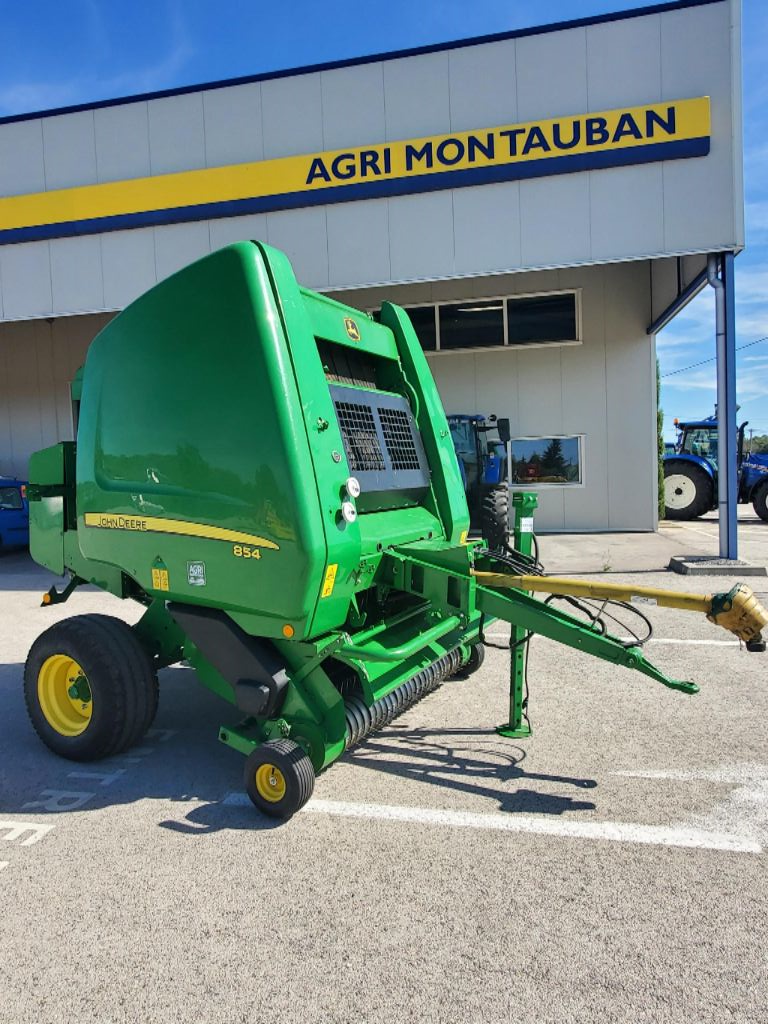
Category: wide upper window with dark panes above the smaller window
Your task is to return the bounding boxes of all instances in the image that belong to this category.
[393,292,581,352]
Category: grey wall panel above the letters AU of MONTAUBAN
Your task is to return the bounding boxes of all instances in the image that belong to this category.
[516,29,589,121]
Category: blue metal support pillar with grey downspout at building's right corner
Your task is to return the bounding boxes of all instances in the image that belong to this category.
[707,253,738,558]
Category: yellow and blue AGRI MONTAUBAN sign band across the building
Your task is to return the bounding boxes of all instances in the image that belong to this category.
[0,96,710,242]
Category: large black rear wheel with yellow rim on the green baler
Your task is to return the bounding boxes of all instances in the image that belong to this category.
[24,614,158,761]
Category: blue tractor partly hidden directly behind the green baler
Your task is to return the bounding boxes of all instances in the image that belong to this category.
[447,414,510,551]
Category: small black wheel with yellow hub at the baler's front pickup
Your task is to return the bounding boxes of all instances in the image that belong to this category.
[244,739,314,818]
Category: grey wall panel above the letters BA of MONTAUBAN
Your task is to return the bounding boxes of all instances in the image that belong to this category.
[586,14,663,111]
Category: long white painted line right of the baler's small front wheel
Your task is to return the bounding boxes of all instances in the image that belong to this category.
[223,793,763,853]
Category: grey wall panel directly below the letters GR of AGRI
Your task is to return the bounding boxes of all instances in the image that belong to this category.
[326,199,391,285]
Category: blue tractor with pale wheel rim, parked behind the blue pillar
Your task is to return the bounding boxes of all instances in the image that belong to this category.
[664,416,768,522]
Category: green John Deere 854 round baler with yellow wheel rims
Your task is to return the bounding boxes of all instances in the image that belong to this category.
[25,243,768,817]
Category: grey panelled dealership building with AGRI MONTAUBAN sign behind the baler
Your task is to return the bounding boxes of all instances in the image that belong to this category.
[0,0,743,530]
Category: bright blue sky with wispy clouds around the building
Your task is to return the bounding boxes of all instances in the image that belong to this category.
[0,0,768,437]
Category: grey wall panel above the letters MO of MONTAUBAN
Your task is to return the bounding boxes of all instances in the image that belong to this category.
[384,53,451,140]
